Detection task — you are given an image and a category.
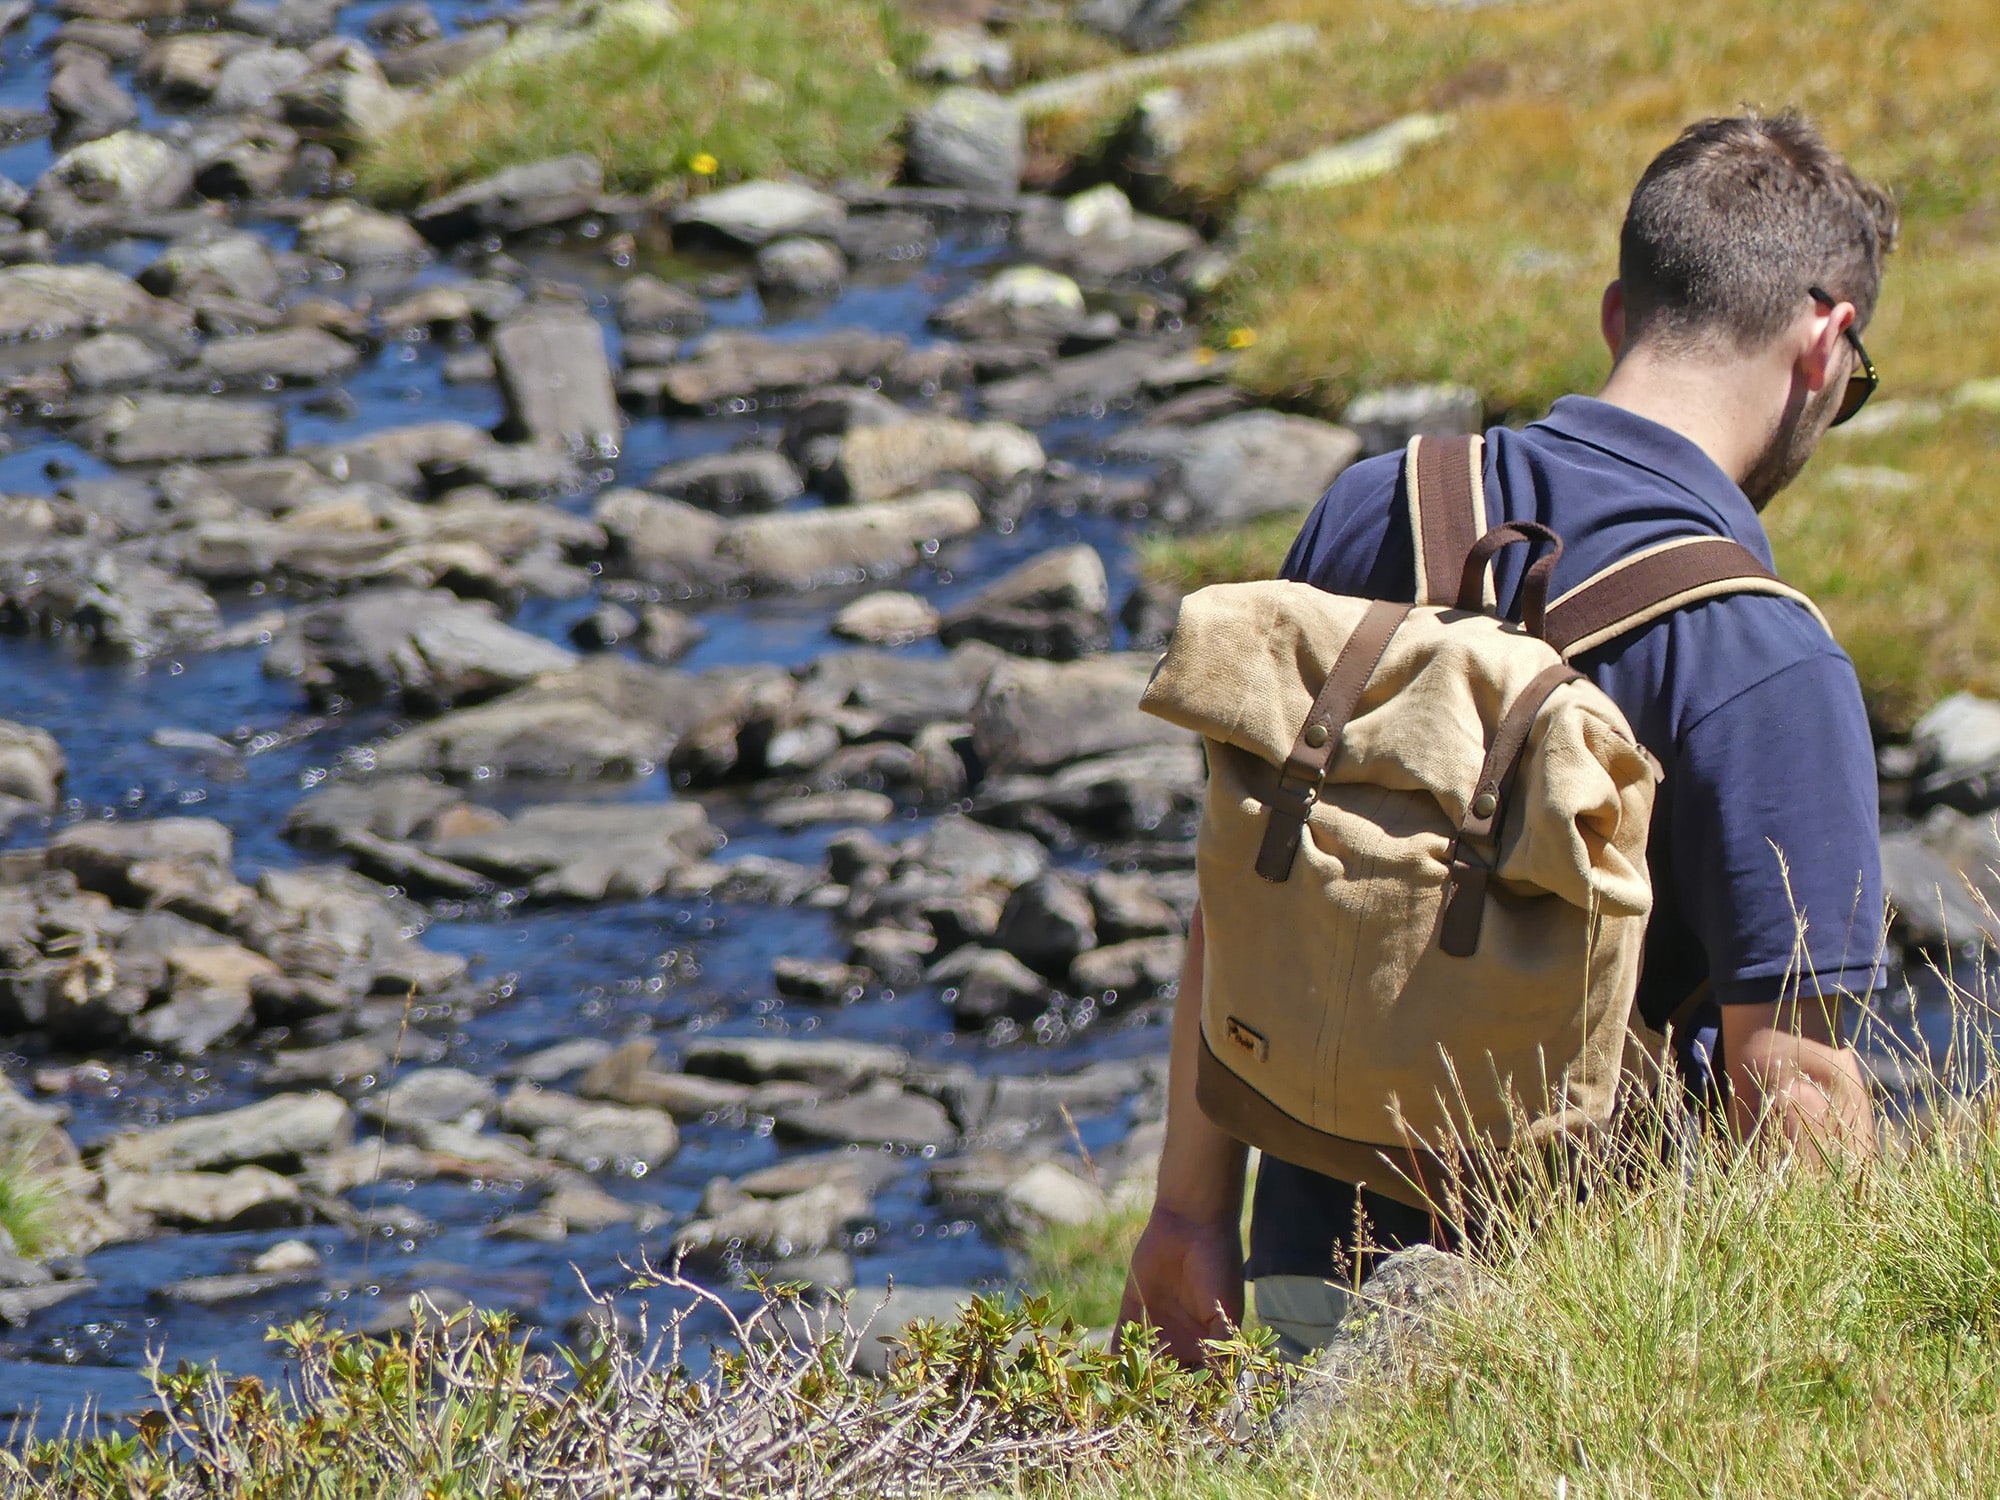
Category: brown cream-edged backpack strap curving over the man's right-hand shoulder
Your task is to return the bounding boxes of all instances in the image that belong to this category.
[1542,536,1826,660]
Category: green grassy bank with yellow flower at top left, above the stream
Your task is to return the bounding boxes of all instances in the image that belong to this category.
[358,0,912,202]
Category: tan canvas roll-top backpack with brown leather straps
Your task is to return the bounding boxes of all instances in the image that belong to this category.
[1144,438,1812,1202]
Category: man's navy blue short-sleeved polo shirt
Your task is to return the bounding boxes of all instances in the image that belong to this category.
[1248,396,1882,1276]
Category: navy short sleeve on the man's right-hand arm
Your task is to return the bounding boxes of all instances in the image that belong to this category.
[1656,654,1882,1004]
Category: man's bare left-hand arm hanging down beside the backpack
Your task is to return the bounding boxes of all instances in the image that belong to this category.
[1118,908,1248,1364]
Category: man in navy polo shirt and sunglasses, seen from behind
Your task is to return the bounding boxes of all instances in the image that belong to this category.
[1120,114,1896,1362]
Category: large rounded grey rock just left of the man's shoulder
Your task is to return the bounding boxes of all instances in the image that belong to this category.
[1156,412,1362,530]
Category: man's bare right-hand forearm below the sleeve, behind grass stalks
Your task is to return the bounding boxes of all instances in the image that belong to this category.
[1722,998,1876,1160]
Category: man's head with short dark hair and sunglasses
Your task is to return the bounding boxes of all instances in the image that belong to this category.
[1604,112,1898,506]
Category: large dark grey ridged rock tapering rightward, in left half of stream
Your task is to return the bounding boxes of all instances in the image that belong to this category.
[264,588,576,708]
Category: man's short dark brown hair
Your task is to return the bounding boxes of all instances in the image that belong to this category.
[1618,110,1898,350]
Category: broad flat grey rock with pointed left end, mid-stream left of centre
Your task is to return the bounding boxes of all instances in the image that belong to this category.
[430,802,716,900]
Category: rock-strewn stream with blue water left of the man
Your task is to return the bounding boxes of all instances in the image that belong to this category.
[0,0,1396,1418]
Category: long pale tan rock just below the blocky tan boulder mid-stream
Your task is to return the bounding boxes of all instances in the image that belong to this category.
[716,490,980,588]
